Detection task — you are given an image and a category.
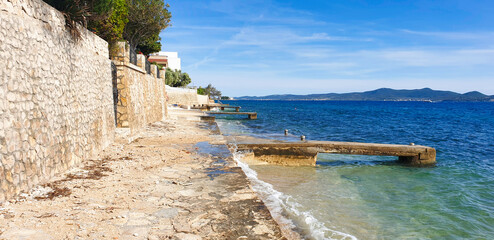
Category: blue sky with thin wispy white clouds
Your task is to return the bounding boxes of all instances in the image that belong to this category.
[161,0,494,96]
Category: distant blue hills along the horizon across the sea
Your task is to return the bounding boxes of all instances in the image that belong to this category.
[237,88,494,102]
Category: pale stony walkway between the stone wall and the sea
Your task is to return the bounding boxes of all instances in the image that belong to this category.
[0,109,294,239]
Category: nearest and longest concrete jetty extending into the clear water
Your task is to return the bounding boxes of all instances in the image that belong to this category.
[237,141,436,167]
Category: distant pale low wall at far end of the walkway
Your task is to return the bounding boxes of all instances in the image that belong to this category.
[166,86,209,106]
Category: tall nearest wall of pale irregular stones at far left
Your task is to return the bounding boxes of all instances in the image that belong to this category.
[0,0,115,202]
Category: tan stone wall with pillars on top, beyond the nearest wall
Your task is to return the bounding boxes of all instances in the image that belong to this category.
[113,42,166,136]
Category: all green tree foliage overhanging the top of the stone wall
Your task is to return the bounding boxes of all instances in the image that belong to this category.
[45,0,171,55]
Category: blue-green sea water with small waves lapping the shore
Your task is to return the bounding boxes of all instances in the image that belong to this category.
[217,101,494,239]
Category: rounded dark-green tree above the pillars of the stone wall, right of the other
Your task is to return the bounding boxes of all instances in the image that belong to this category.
[123,0,171,50]
